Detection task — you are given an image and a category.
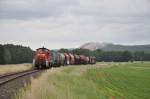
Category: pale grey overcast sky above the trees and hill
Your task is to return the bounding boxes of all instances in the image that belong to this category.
[0,0,150,49]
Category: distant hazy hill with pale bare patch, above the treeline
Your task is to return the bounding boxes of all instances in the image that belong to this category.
[80,42,150,52]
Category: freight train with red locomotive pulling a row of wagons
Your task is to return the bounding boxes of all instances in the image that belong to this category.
[33,48,96,69]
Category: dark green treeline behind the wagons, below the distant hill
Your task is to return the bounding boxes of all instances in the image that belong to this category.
[59,49,150,62]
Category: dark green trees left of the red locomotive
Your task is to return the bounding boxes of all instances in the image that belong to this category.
[0,44,34,64]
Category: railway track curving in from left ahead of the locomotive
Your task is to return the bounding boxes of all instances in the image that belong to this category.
[0,70,40,86]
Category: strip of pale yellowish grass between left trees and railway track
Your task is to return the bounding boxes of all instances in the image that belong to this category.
[0,64,32,75]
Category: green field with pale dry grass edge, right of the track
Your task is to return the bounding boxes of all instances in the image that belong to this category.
[15,62,150,99]
